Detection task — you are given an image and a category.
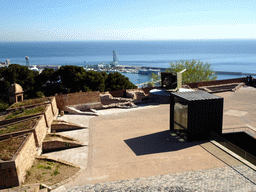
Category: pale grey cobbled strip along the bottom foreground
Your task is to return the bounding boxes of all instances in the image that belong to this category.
[66,165,256,192]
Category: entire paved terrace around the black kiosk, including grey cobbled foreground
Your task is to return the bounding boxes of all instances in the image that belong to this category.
[50,87,256,191]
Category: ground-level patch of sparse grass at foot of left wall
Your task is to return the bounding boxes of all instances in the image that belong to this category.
[24,159,79,185]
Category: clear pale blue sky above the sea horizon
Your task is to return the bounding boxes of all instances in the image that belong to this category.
[0,0,256,41]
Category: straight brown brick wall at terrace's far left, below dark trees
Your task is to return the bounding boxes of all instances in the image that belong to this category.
[55,91,100,110]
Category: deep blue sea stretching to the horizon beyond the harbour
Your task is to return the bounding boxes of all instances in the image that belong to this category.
[0,39,256,84]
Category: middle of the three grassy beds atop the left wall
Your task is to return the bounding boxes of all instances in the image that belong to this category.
[0,118,38,135]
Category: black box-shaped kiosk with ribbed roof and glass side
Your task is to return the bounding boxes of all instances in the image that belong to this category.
[170,91,223,141]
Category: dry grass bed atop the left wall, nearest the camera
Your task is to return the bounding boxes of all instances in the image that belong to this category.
[0,136,26,161]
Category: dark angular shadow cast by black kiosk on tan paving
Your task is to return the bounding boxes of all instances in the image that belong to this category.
[124,130,207,156]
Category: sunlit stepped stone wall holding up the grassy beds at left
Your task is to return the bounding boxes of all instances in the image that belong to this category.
[0,98,58,188]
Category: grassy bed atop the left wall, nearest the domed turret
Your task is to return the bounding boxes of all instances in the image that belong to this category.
[4,106,46,120]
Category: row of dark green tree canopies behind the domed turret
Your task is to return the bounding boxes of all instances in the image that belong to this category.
[0,64,136,101]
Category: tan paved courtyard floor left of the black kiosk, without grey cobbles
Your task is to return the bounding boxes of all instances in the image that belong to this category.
[61,104,238,188]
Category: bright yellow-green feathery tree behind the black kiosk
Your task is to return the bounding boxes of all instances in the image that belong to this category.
[166,60,217,83]
